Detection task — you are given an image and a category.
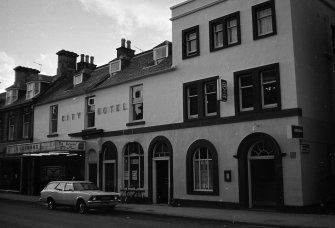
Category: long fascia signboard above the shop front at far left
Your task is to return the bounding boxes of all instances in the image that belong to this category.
[7,140,85,154]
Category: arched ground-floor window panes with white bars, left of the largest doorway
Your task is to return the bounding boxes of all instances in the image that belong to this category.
[193,147,213,191]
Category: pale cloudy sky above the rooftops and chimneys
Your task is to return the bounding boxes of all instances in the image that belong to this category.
[0,0,185,93]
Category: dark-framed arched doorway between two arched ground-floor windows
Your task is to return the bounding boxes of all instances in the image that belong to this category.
[148,136,173,204]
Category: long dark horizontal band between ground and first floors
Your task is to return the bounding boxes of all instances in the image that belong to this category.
[68,108,302,138]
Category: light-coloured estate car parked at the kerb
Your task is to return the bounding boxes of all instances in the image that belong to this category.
[41,181,120,214]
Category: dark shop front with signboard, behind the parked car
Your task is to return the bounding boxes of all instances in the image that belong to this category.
[3,140,85,195]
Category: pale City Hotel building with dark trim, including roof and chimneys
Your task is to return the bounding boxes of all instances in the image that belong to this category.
[2,0,335,210]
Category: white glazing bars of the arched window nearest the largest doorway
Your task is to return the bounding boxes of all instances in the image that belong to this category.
[192,147,214,192]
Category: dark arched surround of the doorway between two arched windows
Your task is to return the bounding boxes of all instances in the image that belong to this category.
[148,136,173,202]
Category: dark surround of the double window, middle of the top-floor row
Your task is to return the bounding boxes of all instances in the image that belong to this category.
[209,11,241,52]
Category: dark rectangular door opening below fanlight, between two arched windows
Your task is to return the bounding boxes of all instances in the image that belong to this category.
[156,160,169,203]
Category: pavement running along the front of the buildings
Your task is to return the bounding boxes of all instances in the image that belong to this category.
[0,192,335,228]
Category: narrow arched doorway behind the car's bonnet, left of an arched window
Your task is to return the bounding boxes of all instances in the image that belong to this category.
[102,142,117,192]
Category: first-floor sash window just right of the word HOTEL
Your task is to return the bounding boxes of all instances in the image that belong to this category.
[130,85,143,121]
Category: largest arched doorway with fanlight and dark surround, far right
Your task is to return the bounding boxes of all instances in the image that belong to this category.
[237,133,284,209]
